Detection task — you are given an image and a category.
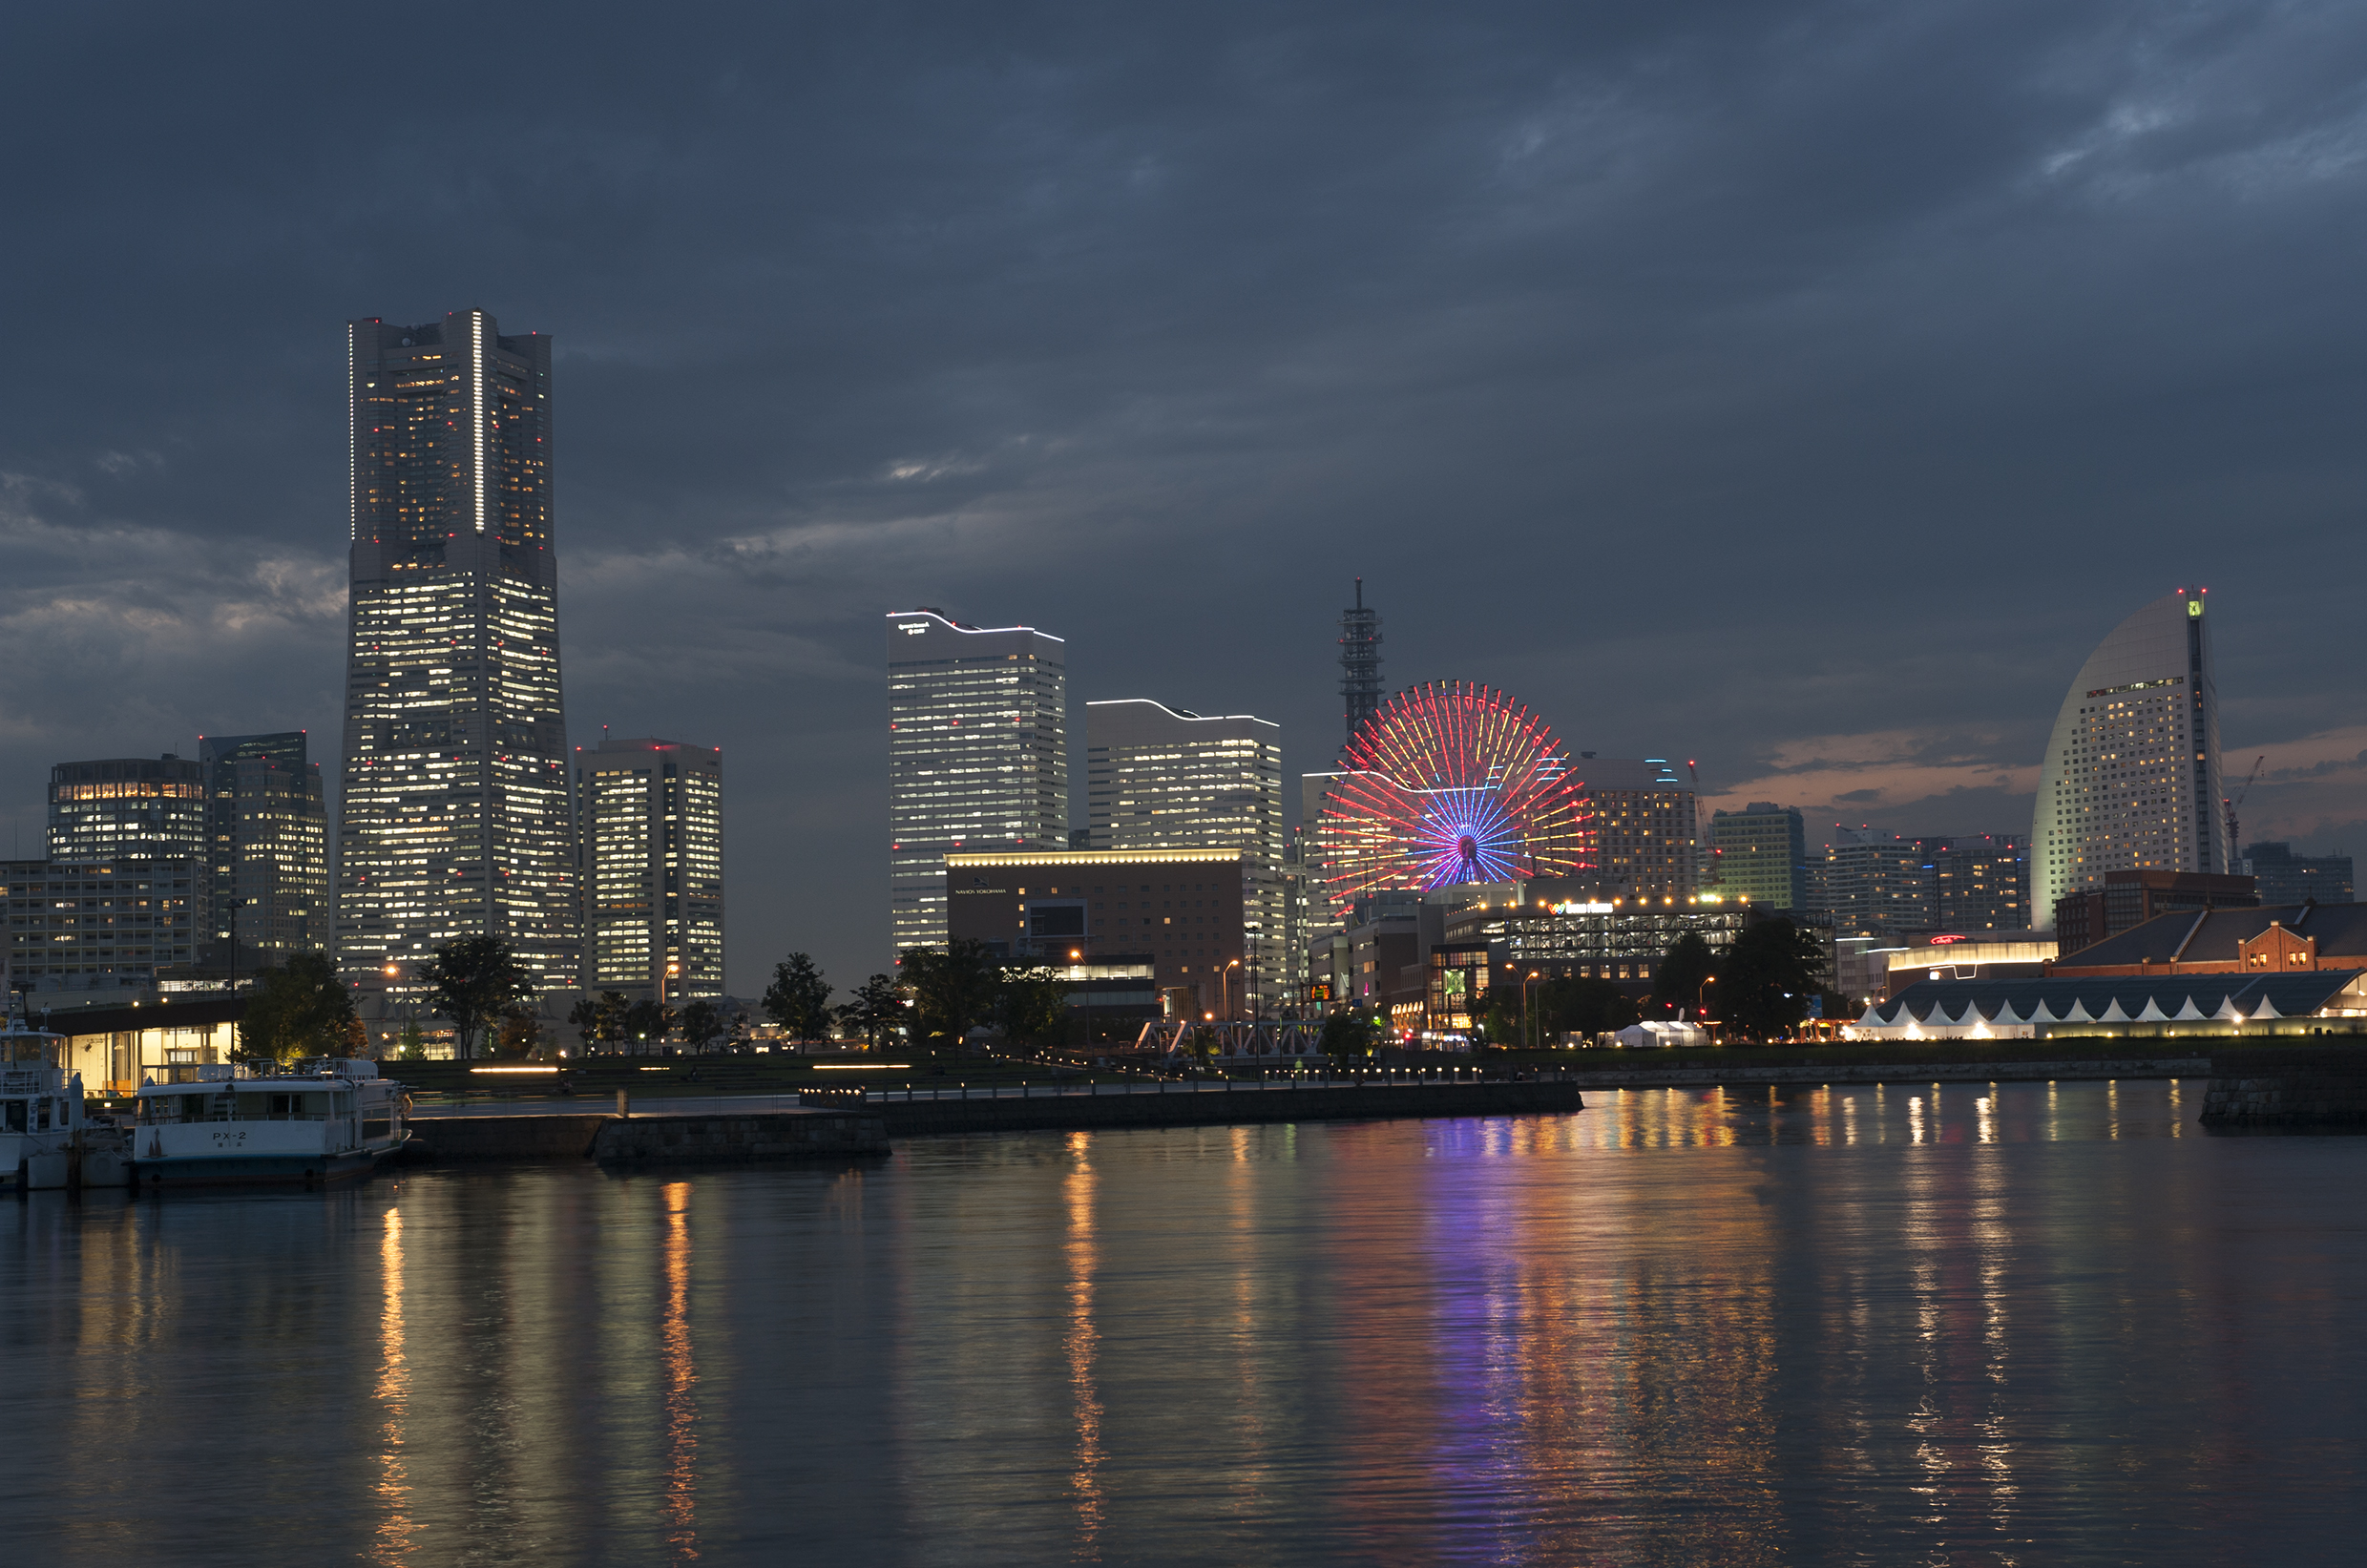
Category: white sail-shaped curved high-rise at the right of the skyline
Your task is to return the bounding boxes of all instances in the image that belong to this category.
[2031,588,2234,929]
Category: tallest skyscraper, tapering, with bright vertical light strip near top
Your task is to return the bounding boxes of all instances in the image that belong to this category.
[336,310,580,1021]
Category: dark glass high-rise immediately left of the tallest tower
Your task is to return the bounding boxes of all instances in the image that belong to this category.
[197,729,331,962]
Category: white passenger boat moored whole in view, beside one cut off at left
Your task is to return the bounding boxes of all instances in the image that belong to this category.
[130,1056,409,1186]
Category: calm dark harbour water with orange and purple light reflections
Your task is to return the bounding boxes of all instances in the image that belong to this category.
[0,1082,2367,1566]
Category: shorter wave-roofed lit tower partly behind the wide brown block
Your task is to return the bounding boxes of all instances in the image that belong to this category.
[1084,699,1292,1018]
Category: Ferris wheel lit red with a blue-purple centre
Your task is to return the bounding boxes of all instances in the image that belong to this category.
[1316,679,1596,912]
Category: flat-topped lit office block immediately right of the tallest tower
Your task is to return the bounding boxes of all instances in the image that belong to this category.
[576,739,724,1004]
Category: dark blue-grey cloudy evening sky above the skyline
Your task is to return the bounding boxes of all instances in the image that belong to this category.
[0,0,2367,993]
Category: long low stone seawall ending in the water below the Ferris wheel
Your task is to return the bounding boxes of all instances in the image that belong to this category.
[871,1082,1586,1137]
